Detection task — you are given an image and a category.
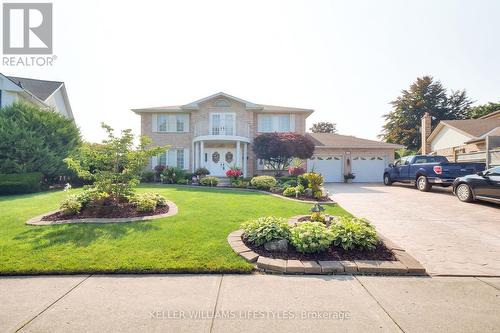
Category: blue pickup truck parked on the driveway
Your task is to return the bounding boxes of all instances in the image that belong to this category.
[384,155,485,192]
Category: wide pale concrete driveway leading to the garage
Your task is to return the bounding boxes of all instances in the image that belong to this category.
[325,183,500,276]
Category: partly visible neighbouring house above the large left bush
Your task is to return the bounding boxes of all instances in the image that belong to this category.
[0,73,74,119]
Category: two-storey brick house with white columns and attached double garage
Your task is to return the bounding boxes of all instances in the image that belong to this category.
[132,92,402,182]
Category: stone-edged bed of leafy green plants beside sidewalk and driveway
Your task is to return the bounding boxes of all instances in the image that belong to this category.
[228,204,425,275]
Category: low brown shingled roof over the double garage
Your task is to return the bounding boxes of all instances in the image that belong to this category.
[306,133,403,149]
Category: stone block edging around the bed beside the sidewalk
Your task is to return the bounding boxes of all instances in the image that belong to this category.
[227,215,427,275]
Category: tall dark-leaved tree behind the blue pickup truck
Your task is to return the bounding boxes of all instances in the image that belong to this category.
[380,76,472,150]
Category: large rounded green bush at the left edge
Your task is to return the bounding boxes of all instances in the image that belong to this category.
[0,103,81,178]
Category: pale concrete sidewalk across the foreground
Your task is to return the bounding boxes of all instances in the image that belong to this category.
[0,274,500,333]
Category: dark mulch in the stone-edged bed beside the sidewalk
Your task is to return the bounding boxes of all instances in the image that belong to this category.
[243,238,396,261]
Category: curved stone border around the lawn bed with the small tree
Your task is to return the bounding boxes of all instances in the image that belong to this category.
[26,201,179,226]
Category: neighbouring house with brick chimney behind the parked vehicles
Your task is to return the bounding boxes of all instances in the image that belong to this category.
[421,110,500,165]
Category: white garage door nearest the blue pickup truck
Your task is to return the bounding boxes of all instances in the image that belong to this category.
[351,156,385,183]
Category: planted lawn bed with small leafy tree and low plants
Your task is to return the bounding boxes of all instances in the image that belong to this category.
[31,125,176,223]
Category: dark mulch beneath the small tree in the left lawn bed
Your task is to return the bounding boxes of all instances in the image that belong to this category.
[42,203,168,221]
